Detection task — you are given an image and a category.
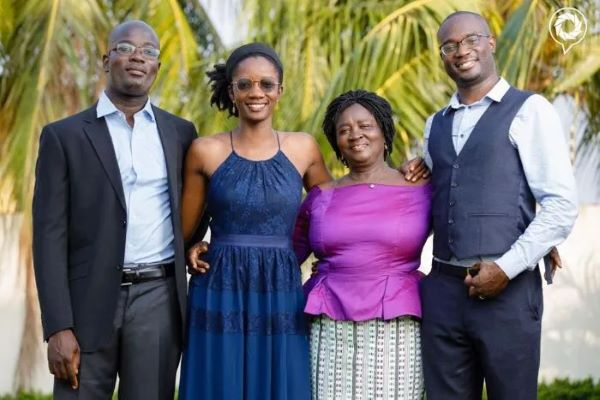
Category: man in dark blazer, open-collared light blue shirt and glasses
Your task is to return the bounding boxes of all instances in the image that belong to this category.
[33,21,206,399]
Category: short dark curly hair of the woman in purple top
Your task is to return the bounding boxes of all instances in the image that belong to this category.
[323,89,396,160]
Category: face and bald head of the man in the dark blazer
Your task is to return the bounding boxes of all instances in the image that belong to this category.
[103,21,160,97]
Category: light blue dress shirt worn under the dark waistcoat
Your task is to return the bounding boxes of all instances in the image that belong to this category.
[423,78,577,279]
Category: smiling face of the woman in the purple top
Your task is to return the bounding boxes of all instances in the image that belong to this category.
[335,103,385,169]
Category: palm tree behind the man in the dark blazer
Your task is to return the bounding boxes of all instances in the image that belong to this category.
[0,0,221,389]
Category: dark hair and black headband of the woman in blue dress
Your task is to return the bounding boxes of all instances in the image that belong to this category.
[206,43,283,117]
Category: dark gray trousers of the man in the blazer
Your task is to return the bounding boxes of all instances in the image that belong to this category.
[54,277,181,400]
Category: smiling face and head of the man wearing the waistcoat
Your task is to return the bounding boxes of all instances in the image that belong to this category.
[438,14,496,88]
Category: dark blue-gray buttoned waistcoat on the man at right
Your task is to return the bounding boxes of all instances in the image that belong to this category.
[428,87,535,260]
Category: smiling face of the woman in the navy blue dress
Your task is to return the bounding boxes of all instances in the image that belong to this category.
[229,56,282,122]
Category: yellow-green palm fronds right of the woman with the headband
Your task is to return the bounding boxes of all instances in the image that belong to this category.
[233,0,600,167]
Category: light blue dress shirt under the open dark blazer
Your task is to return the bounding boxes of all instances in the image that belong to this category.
[96,92,175,265]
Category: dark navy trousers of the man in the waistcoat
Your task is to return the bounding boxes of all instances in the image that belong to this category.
[420,262,543,400]
